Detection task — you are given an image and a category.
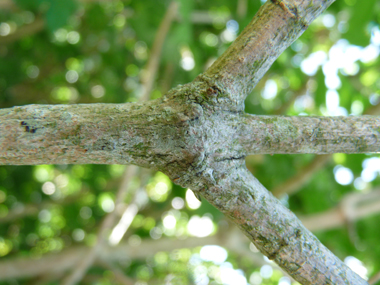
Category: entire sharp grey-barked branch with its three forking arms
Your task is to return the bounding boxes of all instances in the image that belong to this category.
[0,0,372,285]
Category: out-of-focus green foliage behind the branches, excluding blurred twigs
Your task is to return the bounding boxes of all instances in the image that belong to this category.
[0,0,380,285]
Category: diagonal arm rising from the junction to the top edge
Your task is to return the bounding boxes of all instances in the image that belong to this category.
[199,0,335,109]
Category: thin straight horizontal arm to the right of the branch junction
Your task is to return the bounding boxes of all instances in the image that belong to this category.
[240,115,380,154]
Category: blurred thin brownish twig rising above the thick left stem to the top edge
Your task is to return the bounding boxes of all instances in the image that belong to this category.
[141,1,178,101]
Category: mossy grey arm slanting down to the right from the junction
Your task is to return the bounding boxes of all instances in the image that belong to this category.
[196,160,367,285]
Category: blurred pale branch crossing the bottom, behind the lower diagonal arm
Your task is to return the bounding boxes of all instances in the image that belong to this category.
[0,185,380,280]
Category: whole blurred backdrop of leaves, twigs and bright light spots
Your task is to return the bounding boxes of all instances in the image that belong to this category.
[0,0,380,285]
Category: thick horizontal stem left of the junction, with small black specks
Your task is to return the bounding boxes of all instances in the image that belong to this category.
[0,98,202,169]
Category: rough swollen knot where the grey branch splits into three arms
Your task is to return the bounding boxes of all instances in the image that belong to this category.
[163,82,245,191]
